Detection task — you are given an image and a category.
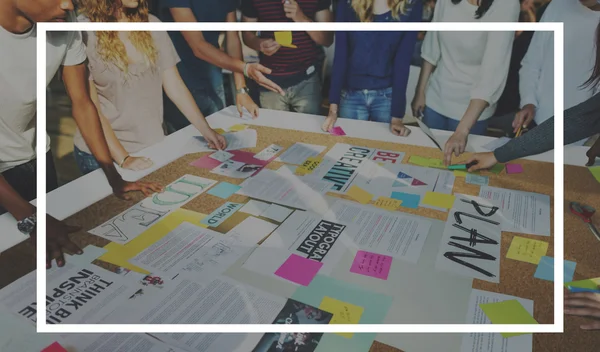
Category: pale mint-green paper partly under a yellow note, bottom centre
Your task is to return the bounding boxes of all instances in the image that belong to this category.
[292,275,392,352]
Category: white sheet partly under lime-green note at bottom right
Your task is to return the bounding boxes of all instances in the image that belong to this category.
[460,289,533,352]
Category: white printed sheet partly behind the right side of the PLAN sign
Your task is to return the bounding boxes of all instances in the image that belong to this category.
[479,186,550,236]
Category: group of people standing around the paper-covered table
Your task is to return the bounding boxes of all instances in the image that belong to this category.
[0,0,600,328]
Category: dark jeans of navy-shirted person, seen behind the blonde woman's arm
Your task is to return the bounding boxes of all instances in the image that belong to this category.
[163,66,225,134]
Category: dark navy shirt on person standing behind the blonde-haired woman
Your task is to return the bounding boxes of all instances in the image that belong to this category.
[160,0,236,90]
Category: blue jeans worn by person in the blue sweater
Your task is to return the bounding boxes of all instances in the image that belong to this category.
[340,87,392,123]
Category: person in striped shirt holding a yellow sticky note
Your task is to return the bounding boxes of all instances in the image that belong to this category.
[241,0,333,115]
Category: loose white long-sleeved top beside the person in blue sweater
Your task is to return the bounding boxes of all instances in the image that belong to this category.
[421,0,520,121]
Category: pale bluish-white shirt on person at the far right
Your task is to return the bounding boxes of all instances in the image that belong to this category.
[519,0,600,124]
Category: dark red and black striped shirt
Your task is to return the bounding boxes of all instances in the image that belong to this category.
[241,0,331,86]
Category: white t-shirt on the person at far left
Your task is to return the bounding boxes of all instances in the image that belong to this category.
[0,14,86,172]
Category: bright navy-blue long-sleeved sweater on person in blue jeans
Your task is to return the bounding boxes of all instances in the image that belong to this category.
[329,0,423,118]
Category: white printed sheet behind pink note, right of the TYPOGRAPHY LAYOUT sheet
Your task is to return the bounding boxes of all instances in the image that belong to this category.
[325,201,431,263]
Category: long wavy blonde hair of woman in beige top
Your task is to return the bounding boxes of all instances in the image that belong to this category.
[79,0,158,73]
